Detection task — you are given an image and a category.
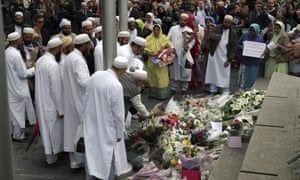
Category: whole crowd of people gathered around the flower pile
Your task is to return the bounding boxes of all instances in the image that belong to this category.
[3,0,300,179]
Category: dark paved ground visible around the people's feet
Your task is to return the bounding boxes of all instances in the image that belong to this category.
[12,69,246,180]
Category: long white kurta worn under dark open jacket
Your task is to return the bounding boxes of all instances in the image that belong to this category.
[205,29,230,87]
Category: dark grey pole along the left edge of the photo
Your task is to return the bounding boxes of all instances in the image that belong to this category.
[0,3,13,180]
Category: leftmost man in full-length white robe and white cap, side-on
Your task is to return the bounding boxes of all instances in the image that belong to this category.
[5,32,36,143]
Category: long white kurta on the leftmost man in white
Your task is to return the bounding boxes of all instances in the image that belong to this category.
[5,46,36,128]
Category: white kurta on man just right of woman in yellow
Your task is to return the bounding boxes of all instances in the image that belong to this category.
[168,25,195,81]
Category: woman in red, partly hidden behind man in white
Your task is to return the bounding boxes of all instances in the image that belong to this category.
[186,14,200,87]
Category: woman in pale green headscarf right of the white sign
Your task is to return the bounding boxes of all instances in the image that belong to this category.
[264,21,289,78]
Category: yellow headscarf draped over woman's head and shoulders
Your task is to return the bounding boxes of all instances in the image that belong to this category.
[145,24,171,53]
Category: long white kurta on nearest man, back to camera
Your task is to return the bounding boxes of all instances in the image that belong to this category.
[83,69,127,179]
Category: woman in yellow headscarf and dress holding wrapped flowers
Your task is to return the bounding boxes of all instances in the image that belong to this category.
[145,24,171,99]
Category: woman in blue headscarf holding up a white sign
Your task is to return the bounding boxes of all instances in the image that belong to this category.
[238,23,264,90]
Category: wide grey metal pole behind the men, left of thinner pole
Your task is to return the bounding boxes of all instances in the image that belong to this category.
[103,0,117,69]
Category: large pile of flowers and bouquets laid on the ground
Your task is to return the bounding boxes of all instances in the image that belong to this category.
[126,90,265,179]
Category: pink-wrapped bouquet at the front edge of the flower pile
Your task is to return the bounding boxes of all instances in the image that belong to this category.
[177,146,205,169]
